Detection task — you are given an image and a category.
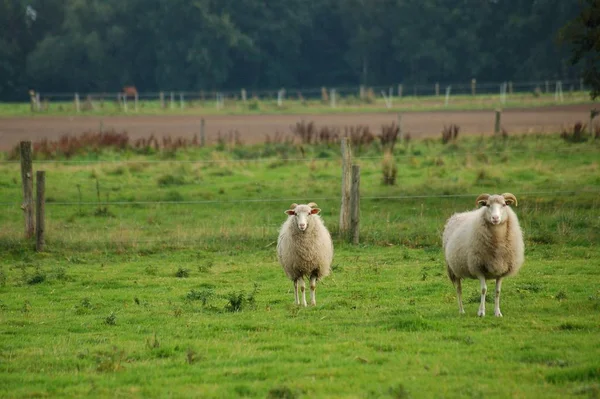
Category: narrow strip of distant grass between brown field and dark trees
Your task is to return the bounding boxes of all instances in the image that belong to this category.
[0,91,592,118]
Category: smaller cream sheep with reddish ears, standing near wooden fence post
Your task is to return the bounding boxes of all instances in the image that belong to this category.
[277,202,333,306]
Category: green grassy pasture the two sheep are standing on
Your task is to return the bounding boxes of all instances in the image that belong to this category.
[0,130,600,398]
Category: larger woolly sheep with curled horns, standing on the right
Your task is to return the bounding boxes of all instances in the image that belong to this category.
[443,193,525,317]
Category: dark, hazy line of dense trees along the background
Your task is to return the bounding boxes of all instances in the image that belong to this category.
[0,0,581,100]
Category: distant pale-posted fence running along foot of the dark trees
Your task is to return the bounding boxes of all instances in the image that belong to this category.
[30,79,586,112]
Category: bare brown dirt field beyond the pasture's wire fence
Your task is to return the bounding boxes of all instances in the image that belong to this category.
[0,104,594,151]
